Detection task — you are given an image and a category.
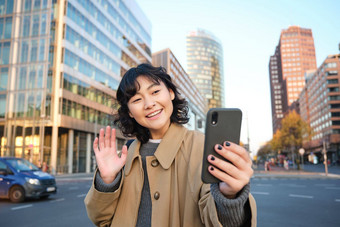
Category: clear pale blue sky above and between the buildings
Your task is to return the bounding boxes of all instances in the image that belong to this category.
[136,0,340,153]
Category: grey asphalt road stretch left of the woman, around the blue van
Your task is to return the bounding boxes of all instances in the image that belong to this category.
[0,177,93,227]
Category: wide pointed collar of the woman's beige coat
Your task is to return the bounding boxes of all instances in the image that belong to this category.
[125,123,187,175]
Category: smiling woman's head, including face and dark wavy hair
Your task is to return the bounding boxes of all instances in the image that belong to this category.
[115,64,189,143]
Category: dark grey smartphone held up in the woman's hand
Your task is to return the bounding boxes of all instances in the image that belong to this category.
[201,108,242,184]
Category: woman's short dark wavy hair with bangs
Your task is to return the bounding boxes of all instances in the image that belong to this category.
[114,64,189,144]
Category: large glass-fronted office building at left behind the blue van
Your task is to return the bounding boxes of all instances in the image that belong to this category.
[0,0,152,173]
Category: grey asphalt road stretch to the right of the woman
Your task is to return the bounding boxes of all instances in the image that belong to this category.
[251,178,340,227]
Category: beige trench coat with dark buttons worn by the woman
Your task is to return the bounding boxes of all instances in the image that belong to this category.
[85,123,257,227]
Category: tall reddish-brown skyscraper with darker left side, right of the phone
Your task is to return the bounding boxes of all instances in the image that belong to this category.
[269,26,316,133]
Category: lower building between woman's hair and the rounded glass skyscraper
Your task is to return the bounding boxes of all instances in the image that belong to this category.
[152,49,208,133]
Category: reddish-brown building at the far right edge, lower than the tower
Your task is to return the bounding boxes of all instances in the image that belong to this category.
[299,54,340,162]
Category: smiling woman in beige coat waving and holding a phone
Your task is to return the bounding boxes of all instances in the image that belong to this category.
[85,64,256,227]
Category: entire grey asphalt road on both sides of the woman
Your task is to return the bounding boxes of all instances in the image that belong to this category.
[0,178,340,227]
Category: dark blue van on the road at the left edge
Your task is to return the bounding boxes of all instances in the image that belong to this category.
[0,157,57,203]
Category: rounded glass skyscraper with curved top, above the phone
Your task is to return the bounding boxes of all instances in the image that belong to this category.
[187,30,225,108]
